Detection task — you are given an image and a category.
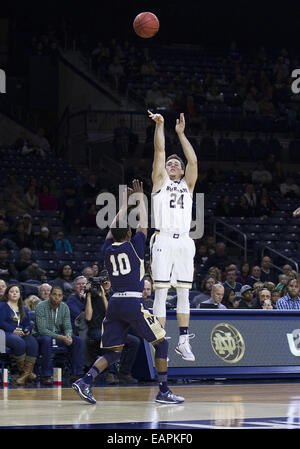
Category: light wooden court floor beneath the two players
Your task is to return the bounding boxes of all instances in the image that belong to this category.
[0,381,300,430]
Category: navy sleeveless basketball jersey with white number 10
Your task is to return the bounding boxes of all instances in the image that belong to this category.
[102,232,146,293]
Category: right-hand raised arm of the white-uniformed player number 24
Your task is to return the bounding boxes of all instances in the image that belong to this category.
[175,113,198,192]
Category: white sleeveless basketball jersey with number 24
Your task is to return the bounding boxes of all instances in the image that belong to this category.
[152,179,193,233]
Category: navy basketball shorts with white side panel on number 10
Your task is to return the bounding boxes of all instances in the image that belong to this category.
[101,292,166,349]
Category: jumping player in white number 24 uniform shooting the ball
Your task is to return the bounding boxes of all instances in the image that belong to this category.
[148,111,198,361]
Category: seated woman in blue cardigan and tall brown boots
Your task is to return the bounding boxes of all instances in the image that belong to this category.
[0,284,38,385]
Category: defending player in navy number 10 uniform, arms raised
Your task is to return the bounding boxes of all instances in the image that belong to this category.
[72,180,184,404]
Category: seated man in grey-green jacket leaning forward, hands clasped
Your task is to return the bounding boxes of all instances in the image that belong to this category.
[32,287,83,385]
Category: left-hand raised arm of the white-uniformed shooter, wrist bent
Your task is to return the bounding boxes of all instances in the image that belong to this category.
[147,110,167,192]
